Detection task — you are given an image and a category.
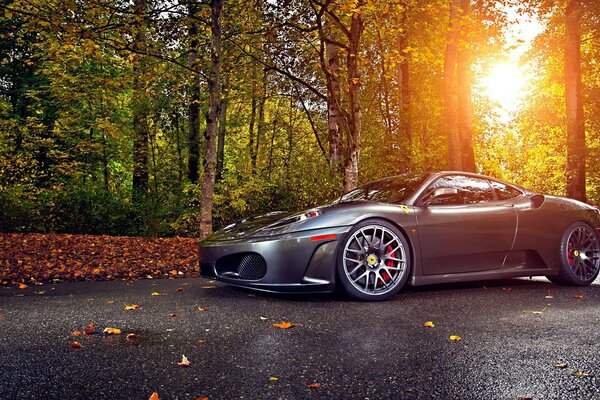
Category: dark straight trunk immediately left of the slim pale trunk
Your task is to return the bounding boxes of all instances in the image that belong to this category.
[188,1,200,183]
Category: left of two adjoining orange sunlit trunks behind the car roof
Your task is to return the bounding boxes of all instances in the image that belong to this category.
[444,0,462,170]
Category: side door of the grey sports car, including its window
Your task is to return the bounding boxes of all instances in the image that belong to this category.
[417,174,517,275]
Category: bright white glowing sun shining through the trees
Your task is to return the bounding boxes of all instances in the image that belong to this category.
[481,62,528,113]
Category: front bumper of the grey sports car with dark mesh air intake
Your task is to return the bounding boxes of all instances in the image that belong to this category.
[200,226,351,293]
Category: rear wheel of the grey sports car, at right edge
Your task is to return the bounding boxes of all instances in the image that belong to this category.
[546,222,600,286]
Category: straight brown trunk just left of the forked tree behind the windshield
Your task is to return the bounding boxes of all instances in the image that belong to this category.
[326,43,343,173]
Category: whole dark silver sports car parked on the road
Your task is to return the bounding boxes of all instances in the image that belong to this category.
[200,171,600,300]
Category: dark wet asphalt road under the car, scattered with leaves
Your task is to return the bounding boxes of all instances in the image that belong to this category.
[0,278,600,400]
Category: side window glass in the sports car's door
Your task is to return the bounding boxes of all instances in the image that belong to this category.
[429,175,494,205]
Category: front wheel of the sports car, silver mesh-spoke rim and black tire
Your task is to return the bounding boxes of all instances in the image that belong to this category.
[336,219,411,301]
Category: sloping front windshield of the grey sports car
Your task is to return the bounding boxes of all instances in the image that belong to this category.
[337,174,429,203]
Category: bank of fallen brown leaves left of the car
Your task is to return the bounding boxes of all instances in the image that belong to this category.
[0,233,198,288]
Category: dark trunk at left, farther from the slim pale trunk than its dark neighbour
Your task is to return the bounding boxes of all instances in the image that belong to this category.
[132,0,150,203]
